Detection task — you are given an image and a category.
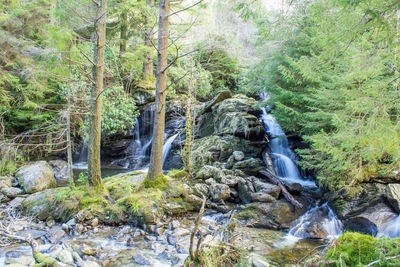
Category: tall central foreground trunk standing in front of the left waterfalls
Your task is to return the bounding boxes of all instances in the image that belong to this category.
[148,0,169,180]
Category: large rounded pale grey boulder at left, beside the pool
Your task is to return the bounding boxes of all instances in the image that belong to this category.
[15,161,56,194]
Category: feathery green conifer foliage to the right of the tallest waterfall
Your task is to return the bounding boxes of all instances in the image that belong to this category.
[241,0,400,189]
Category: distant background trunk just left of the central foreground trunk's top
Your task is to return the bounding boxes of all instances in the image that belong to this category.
[143,0,154,80]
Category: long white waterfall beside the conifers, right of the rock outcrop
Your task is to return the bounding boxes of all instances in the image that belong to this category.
[261,109,316,188]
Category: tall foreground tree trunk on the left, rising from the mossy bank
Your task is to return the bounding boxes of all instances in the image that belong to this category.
[88,0,107,190]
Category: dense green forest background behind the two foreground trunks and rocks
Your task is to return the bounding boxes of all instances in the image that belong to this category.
[0,0,400,195]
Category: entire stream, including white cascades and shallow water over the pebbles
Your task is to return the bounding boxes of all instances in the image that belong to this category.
[7,103,400,266]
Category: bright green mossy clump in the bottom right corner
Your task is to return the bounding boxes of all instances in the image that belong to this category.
[325,232,400,266]
